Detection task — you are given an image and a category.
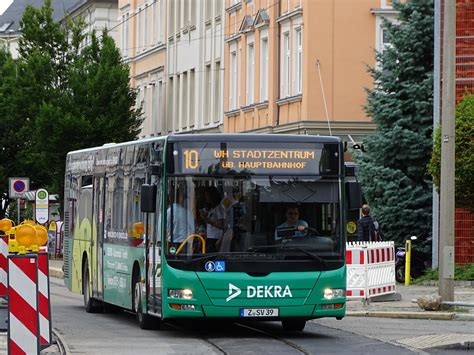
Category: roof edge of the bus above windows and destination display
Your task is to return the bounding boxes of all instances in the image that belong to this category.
[68,133,341,155]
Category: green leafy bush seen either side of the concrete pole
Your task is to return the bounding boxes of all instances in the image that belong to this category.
[428,95,474,212]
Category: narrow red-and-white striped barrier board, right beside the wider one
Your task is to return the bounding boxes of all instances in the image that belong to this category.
[38,252,51,349]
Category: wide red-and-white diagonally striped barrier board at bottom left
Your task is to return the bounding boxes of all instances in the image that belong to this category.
[8,254,40,355]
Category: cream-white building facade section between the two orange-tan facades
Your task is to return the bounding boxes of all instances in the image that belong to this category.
[164,0,224,133]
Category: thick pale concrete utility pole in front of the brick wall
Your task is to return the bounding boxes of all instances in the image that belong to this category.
[438,0,456,301]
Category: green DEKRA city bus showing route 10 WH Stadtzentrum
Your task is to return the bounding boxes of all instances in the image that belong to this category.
[64,134,360,330]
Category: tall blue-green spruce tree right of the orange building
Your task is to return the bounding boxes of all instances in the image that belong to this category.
[356,0,434,242]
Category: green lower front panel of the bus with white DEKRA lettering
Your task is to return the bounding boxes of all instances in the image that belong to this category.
[163,265,346,319]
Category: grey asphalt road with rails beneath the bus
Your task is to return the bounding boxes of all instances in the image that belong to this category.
[51,278,472,354]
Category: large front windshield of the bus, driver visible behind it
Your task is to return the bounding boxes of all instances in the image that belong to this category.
[165,175,343,271]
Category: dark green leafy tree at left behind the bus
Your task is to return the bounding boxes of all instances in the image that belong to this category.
[0,0,142,217]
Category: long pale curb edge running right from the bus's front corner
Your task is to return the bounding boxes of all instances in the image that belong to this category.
[346,311,474,321]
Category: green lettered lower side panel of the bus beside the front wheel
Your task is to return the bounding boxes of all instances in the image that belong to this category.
[103,243,144,309]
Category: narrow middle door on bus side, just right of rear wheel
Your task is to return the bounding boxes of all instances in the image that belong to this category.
[91,175,105,299]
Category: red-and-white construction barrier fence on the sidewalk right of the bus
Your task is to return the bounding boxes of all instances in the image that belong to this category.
[346,242,395,300]
